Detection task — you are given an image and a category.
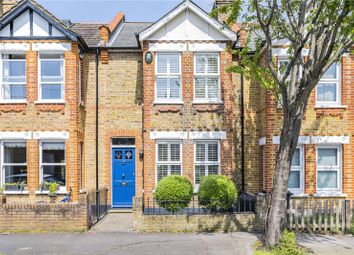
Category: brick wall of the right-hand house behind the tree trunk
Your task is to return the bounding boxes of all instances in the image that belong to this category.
[258,54,354,199]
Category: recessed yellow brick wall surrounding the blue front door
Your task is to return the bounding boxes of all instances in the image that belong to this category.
[83,52,142,205]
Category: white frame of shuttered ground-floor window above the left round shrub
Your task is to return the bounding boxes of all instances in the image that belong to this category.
[155,140,183,185]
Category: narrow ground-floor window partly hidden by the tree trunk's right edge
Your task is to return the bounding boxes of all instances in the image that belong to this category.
[288,146,304,193]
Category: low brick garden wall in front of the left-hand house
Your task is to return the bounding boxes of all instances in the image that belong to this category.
[0,194,88,233]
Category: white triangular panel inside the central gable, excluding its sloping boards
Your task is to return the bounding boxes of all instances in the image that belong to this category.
[148,9,229,41]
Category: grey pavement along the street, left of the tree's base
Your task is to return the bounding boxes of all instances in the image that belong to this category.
[0,232,257,255]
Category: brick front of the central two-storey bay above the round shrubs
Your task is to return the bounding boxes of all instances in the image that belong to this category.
[143,42,239,196]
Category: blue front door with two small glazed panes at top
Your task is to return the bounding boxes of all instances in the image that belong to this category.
[112,148,135,207]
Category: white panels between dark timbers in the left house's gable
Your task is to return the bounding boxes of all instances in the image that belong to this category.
[0,10,64,37]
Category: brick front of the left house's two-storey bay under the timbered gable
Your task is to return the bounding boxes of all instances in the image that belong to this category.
[0,40,83,201]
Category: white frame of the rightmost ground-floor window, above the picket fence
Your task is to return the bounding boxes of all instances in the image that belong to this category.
[316,144,343,195]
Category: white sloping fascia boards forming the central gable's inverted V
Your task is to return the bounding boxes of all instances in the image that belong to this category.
[139,1,237,42]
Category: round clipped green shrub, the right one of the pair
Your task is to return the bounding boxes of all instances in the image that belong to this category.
[198,175,237,211]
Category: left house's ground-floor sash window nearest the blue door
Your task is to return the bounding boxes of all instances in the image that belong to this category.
[40,141,66,186]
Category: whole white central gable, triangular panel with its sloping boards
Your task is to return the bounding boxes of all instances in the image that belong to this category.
[139,1,237,42]
